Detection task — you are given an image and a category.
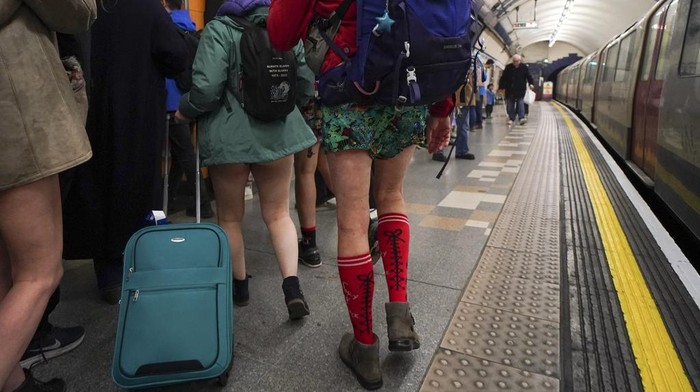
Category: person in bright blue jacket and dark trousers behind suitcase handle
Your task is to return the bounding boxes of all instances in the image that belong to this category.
[164,0,214,219]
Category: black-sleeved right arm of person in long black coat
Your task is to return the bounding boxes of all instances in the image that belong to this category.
[150,0,187,78]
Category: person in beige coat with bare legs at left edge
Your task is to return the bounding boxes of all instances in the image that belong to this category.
[0,0,96,392]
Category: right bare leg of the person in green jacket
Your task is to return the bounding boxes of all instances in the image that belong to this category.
[251,155,299,278]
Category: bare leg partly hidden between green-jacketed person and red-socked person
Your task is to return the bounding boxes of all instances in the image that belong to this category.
[294,143,320,228]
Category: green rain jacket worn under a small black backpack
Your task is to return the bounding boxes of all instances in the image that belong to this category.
[180,7,316,166]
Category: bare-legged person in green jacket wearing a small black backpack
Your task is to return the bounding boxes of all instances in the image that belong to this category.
[175,0,317,320]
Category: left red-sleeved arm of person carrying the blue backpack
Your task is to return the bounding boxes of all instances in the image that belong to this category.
[267,0,315,51]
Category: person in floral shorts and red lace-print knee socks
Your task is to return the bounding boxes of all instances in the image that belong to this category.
[268,0,453,389]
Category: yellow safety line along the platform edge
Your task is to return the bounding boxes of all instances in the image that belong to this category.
[554,104,693,392]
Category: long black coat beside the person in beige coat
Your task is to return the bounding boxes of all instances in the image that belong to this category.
[64,0,187,259]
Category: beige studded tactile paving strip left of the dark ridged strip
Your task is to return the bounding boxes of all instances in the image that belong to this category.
[421,107,561,391]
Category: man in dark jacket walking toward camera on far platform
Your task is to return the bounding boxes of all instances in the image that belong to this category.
[498,54,534,125]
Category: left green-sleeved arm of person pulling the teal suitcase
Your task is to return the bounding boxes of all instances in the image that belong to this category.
[180,20,236,118]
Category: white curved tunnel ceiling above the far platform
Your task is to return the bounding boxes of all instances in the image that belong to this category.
[474,0,656,55]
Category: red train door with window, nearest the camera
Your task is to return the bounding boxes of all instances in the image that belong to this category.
[631,0,678,180]
